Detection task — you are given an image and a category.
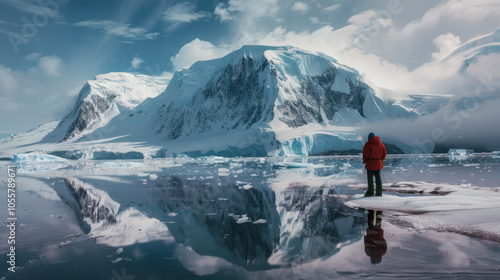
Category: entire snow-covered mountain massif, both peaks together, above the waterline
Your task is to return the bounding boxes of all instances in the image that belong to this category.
[1,46,416,158]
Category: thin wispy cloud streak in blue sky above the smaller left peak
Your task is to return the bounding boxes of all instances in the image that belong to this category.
[74,20,160,40]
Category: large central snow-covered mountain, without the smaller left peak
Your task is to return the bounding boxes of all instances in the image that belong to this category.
[76,46,415,156]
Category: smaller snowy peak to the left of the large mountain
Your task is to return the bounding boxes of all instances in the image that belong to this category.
[44,73,168,142]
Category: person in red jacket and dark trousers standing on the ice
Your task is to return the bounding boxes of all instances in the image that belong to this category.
[363,132,387,196]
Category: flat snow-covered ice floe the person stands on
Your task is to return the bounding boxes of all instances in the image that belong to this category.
[346,182,500,240]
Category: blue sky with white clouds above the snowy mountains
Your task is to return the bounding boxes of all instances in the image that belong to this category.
[0,0,500,139]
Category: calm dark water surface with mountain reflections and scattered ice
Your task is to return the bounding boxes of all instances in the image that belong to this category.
[0,155,500,279]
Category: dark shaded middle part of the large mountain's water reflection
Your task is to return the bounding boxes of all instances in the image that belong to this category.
[154,176,280,269]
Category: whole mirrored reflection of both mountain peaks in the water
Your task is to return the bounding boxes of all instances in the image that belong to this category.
[53,173,366,270]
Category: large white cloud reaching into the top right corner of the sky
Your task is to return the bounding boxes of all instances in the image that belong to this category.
[382,0,500,67]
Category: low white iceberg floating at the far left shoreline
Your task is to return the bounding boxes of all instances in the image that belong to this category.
[12,153,70,172]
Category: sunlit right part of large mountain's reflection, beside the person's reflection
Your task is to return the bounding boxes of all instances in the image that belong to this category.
[273,183,365,263]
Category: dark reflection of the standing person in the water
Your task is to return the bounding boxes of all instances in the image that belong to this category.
[365,210,387,264]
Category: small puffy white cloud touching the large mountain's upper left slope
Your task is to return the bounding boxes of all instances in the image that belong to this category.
[170,38,229,71]
